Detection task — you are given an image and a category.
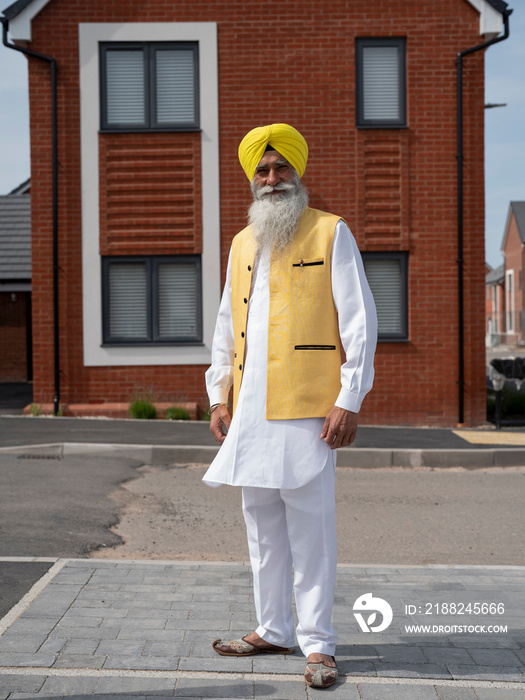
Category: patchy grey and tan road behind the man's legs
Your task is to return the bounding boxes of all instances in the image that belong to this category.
[0,454,525,565]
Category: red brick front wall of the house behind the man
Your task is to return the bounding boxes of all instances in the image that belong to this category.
[26,0,485,425]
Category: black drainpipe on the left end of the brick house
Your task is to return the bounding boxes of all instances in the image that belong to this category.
[0,17,60,416]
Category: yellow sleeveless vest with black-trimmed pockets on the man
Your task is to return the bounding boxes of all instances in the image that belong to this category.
[231,208,341,420]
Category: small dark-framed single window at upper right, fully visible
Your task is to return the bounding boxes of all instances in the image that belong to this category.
[356,38,407,128]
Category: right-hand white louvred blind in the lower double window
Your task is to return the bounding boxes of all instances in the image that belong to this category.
[158,263,198,340]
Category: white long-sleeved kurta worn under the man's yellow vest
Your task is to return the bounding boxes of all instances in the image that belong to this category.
[203,221,377,489]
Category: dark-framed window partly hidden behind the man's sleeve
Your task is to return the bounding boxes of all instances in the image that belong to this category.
[362,253,408,340]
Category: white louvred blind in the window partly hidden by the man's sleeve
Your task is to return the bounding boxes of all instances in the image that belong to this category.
[363,258,403,335]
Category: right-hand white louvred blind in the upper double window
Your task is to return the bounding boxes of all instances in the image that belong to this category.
[155,49,195,124]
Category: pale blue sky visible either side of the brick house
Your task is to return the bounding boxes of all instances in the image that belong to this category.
[0,0,525,267]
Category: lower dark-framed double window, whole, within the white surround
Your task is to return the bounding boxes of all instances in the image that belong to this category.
[102,255,202,345]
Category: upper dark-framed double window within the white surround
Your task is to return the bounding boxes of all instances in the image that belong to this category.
[100,42,199,131]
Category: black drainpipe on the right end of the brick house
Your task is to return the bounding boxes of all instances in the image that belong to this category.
[456,10,512,424]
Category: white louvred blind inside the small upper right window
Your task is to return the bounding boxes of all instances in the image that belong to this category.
[363,46,401,121]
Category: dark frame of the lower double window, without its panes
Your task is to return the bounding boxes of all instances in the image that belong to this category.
[102,255,203,347]
